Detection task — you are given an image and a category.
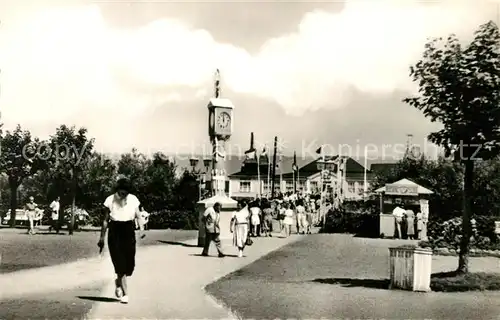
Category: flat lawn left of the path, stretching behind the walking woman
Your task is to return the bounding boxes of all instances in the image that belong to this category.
[0,228,197,273]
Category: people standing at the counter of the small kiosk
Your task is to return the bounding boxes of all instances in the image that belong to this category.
[392,204,428,240]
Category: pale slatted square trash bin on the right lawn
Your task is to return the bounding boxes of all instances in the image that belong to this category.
[389,246,432,292]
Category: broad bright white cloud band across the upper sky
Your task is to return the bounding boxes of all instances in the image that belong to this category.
[0,0,491,127]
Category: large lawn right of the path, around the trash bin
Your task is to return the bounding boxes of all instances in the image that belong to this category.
[206,235,500,319]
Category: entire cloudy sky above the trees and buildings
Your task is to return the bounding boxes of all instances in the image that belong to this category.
[0,0,498,160]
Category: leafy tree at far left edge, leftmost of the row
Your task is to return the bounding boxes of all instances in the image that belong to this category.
[0,125,44,227]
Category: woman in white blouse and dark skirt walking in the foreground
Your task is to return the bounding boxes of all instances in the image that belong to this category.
[97,178,145,303]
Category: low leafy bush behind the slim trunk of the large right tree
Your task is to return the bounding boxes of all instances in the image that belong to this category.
[428,216,500,250]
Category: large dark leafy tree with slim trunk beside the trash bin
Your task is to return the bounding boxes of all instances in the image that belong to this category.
[403,21,500,273]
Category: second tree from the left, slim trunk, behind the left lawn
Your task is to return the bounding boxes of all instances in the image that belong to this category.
[50,125,94,234]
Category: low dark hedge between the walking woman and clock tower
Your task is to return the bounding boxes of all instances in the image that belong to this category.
[148,210,198,230]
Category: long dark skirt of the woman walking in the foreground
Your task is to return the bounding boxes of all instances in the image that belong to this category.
[108,221,135,277]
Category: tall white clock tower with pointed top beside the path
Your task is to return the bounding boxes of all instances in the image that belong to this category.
[198,69,237,246]
